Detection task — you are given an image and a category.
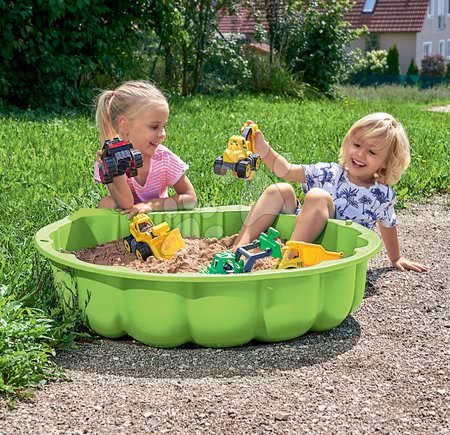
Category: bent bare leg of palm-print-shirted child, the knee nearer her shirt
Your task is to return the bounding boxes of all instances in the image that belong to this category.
[291,188,336,243]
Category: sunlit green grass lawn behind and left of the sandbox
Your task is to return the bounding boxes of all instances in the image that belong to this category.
[0,88,450,408]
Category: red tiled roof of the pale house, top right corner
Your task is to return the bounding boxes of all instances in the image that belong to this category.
[347,0,429,32]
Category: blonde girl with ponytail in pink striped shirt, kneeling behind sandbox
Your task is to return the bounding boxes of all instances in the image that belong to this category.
[94,81,197,218]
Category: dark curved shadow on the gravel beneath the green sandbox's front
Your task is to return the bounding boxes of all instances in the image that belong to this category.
[55,316,361,379]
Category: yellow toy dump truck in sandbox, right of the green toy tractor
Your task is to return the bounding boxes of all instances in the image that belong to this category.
[273,240,344,269]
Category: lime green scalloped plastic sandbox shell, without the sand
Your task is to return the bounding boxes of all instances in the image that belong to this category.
[35,206,381,347]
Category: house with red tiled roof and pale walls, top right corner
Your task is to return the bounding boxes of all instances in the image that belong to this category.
[347,0,450,74]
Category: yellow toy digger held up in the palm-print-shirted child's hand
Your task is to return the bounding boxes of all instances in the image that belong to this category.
[214,122,261,180]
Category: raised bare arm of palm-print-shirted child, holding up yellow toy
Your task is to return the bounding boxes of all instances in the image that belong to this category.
[255,130,305,183]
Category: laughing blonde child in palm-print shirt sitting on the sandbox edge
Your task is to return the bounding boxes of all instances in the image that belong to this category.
[234,113,427,272]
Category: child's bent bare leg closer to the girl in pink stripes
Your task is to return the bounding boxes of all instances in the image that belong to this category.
[233,183,297,248]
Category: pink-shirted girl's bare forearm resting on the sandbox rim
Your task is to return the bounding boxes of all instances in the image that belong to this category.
[121,174,197,219]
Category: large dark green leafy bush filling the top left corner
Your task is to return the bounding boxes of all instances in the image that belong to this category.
[0,0,152,107]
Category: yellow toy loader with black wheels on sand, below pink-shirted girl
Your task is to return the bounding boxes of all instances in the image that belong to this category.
[123,214,186,261]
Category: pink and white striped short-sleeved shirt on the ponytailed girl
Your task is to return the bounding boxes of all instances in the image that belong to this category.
[94,145,189,204]
